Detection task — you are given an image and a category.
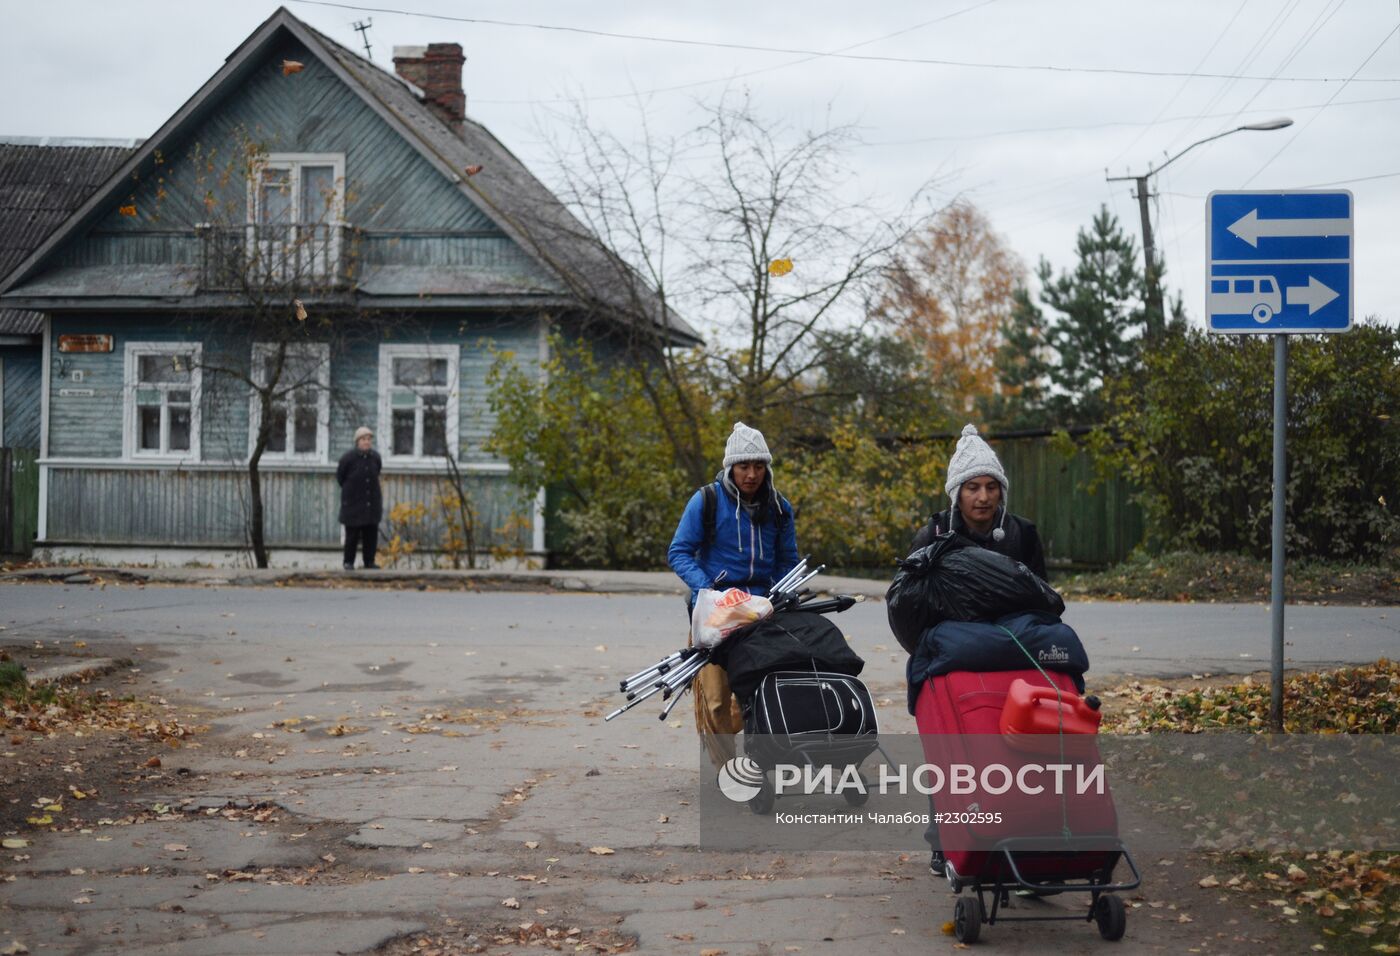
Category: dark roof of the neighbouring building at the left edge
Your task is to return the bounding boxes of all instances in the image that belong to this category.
[0,137,136,335]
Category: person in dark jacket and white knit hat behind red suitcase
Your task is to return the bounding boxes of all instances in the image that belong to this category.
[909,424,1046,876]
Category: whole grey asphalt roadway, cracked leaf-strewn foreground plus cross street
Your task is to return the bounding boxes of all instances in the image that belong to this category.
[0,585,1400,956]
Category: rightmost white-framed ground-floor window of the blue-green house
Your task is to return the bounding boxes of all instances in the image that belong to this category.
[379,346,459,461]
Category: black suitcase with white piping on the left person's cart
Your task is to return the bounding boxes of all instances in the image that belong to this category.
[743,670,879,767]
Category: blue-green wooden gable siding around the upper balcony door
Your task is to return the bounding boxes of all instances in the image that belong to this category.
[55,39,547,284]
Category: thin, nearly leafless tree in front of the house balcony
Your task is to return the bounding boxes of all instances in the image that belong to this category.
[147,133,379,567]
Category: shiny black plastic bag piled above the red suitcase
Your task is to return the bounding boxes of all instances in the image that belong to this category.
[885,532,1064,654]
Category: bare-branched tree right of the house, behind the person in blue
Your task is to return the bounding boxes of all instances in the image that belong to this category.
[509,97,931,483]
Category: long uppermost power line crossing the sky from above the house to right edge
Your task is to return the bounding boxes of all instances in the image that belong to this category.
[293,0,1400,83]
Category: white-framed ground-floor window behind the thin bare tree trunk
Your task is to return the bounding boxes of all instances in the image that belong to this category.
[248,342,330,462]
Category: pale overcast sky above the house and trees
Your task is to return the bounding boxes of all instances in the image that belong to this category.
[0,0,1400,323]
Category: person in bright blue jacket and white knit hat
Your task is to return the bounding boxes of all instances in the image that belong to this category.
[666,421,797,767]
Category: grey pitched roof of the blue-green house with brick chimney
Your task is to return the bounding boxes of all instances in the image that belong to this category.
[0,7,701,344]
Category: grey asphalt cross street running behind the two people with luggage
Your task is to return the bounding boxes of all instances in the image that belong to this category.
[0,586,1400,677]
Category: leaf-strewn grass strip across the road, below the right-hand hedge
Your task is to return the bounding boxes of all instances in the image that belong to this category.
[1054,551,1400,605]
